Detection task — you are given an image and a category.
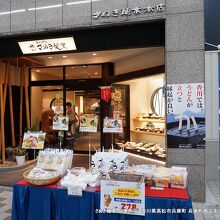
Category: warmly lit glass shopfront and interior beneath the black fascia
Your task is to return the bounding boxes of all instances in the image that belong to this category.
[30,47,166,161]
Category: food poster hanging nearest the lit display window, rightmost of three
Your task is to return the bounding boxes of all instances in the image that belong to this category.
[103,118,123,133]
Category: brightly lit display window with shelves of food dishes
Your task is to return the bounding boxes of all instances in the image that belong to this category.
[116,76,166,162]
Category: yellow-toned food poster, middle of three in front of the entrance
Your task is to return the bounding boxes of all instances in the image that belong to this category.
[79,114,98,132]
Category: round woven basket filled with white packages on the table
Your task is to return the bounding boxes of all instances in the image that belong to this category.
[23,167,60,186]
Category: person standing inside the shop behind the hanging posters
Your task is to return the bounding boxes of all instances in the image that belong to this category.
[66,102,79,136]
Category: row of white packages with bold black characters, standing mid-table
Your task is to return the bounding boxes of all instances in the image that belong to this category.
[91,151,128,175]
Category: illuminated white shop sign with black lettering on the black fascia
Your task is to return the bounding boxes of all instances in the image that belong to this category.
[18,37,76,54]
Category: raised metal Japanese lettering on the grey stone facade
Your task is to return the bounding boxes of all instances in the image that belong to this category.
[92,3,165,19]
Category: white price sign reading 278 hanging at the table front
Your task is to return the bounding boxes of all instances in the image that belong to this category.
[100,180,145,216]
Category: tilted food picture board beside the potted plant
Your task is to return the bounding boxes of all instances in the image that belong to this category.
[22,132,46,149]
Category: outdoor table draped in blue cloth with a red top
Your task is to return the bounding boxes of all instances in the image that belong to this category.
[12,180,194,220]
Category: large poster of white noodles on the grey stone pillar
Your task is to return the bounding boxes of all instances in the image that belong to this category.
[167,83,205,148]
